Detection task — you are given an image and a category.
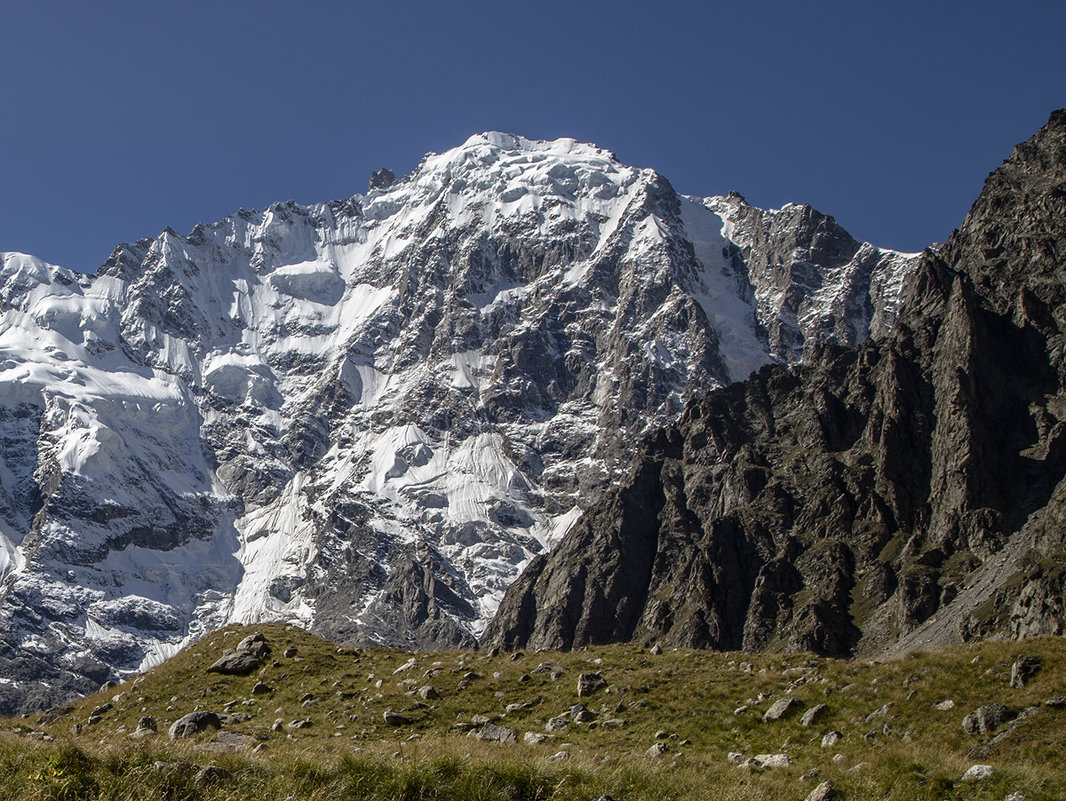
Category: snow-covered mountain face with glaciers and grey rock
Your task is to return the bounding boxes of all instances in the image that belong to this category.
[0,133,917,712]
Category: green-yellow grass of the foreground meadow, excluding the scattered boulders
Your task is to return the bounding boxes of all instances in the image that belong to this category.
[0,624,1066,801]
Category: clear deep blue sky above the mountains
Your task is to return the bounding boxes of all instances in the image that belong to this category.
[0,0,1066,271]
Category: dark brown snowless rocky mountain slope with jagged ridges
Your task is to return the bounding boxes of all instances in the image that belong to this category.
[485,110,1066,655]
